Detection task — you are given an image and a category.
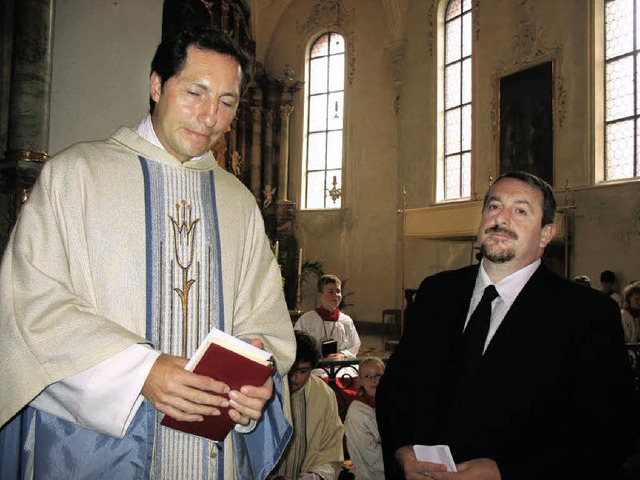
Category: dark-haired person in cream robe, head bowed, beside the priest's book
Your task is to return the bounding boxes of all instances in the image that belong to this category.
[267,331,344,480]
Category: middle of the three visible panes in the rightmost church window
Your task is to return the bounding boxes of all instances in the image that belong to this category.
[605,57,634,121]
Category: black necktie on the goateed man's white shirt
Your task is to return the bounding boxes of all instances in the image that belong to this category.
[460,285,498,379]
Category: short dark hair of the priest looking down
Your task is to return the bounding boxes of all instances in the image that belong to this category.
[149,24,250,113]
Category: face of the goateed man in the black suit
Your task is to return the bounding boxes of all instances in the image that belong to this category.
[478,178,555,269]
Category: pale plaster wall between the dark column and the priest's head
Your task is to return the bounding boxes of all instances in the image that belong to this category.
[49,0,163,154]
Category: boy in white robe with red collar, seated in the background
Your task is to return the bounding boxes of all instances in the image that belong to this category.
[294,275,360,375]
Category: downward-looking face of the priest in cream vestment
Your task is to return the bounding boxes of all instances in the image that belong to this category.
[150,46,242,163]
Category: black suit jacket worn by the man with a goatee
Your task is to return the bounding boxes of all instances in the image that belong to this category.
[376,265,637,480]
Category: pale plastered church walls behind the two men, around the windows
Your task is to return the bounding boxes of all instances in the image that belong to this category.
[49,0,640,322]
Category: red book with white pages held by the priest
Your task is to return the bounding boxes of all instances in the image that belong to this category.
[160,329,274,441]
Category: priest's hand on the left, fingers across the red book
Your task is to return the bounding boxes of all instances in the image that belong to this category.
[141,353,231,423]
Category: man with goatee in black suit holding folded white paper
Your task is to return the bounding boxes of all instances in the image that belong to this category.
[376,172,636,480]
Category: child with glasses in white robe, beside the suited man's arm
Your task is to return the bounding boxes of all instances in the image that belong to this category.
[344,357,384,480]
